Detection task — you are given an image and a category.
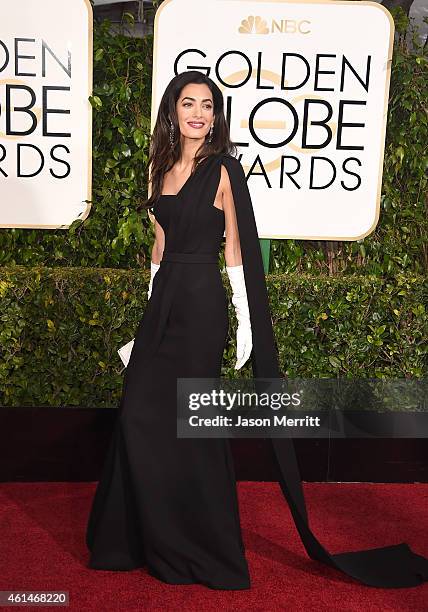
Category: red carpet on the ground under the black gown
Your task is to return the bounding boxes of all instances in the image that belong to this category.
[0,482,428,612]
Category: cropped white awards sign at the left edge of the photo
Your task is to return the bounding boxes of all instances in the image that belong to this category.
[0,0,93,229]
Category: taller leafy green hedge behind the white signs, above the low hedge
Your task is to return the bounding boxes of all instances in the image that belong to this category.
[0,10,428,276]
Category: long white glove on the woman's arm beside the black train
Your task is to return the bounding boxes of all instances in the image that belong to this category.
[226,264,253,370]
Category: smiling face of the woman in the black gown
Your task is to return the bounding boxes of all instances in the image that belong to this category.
[176,83,214,140]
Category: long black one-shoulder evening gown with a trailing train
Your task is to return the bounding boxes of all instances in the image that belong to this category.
[86,155,428,589]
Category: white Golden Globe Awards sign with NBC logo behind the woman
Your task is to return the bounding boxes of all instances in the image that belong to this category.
[152,0,394,240]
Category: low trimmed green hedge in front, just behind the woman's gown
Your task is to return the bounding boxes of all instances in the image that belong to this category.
[0,266,428,407]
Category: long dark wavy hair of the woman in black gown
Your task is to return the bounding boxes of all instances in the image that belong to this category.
[137,70,236,210]
